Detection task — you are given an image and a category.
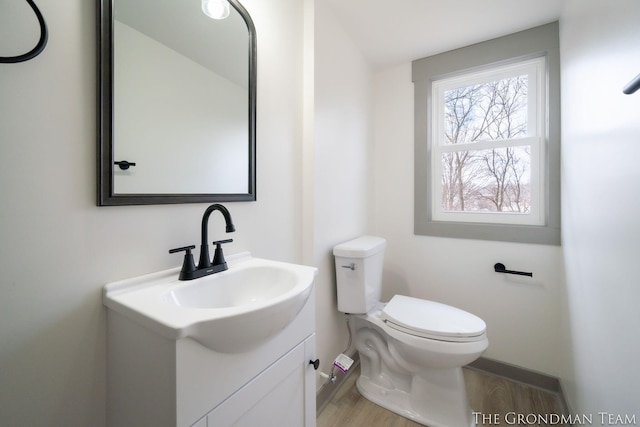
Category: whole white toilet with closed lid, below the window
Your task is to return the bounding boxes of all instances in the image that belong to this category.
[333,236,489,427]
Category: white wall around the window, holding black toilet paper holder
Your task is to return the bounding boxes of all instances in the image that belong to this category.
[373,63,564,375]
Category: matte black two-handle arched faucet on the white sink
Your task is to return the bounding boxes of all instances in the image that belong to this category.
[169,204,236,280]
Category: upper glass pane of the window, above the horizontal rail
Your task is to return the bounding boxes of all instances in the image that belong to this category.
[444,75,528,144]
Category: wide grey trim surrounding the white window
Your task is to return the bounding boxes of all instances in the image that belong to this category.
[412,22,561,245]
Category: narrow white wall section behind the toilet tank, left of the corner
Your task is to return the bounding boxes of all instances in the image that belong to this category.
[308,1,372,387]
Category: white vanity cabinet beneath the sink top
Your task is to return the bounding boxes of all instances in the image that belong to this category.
[107,280,316,427]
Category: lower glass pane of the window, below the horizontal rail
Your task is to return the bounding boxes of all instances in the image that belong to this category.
[442,146,531,214]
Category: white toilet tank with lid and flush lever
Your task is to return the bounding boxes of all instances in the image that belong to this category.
[333,236,387,314]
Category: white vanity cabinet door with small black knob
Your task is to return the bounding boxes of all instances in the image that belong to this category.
[205,334,315,427]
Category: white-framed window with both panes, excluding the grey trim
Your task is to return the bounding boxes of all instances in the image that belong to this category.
[430,58,545,225]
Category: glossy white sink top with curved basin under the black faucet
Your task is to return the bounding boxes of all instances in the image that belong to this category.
[103,252,317,353]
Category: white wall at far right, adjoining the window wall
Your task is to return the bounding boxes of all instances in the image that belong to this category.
[560,0,640,418]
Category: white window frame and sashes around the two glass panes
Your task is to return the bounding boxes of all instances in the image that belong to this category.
[431,57,546,229]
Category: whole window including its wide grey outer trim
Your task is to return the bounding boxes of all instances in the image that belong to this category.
[413,23,560,244]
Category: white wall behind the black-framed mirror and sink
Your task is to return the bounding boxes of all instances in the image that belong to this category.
[0,0,303,427]
